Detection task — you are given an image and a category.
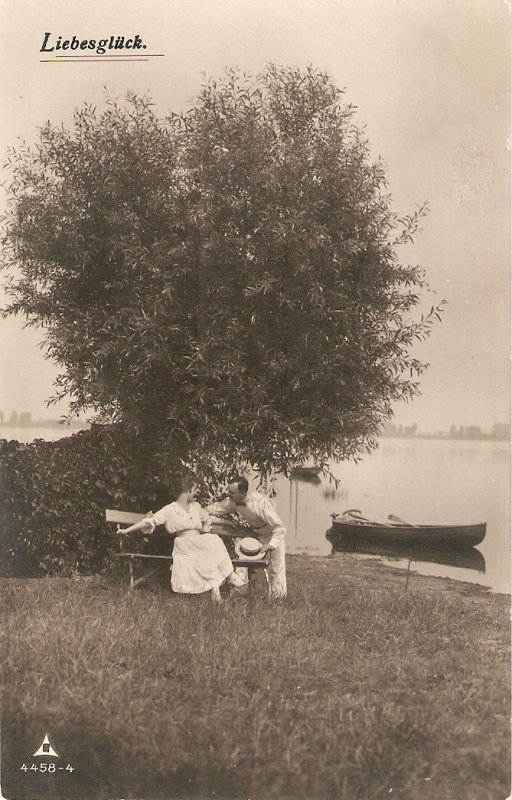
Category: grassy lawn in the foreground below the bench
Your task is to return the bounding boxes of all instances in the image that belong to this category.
[1,556,510,800]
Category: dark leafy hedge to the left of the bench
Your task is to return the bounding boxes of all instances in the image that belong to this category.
[0,426,178,575]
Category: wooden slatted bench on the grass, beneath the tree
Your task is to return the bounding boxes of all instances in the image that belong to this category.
[105,508,270,590]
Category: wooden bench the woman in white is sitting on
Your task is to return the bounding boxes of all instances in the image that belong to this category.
[105,508,270,591]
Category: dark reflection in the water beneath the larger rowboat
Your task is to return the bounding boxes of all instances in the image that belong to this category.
[325,527,485,573]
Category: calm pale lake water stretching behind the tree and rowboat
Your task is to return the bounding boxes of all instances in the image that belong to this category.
[0,432,511,592]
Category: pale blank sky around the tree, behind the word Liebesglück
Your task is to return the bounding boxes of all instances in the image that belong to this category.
[0,0,511,431]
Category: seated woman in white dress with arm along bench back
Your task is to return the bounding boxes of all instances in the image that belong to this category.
[119,475,244,600]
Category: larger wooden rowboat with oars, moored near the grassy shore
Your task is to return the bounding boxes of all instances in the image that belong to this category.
[331,508,486,547]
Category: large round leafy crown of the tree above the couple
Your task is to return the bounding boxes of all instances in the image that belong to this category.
[4,66,438,473]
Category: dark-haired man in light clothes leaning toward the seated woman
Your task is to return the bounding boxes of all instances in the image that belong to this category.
[208,475,286,597]
